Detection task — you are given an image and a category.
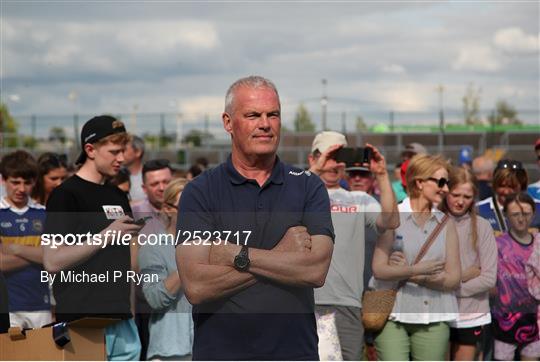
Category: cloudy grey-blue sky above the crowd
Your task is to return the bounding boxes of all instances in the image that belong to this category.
[0,1,540,135]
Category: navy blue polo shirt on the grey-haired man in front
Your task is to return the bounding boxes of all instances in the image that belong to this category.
[177,156,334,360]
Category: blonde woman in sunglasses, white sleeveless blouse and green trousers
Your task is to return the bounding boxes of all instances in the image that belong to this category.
[370,155,461,360]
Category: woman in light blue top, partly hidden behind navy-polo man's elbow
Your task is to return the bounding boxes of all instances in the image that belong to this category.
[139,179,193,360]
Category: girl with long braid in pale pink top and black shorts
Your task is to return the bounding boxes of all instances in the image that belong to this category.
[440,167,497,361]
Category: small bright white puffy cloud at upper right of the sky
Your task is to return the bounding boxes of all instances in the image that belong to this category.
[452,45,502,72]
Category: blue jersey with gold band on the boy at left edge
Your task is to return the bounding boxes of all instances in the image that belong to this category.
[0,199,50,312]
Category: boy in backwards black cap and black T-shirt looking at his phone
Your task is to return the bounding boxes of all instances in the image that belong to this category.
[42,116,141,360]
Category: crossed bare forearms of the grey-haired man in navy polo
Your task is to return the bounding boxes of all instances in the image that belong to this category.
[176,226,334,304]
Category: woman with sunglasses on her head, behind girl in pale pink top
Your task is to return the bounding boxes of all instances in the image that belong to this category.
[476,159,540,236]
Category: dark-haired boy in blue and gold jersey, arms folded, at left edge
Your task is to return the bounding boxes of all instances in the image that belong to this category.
[0,151,52,328]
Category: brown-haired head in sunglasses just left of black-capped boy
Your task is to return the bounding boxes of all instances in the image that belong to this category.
[32,152,67,205]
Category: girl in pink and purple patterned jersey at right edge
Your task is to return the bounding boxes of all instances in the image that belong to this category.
[492,192,540,361]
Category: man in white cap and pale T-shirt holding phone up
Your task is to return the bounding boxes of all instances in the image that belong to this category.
[308,131,399,360]
